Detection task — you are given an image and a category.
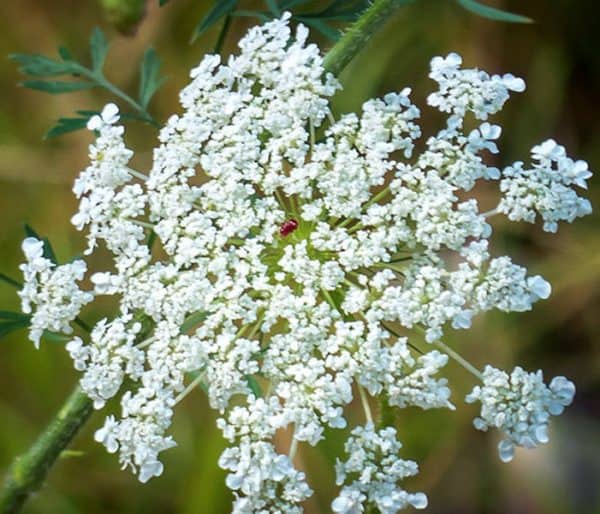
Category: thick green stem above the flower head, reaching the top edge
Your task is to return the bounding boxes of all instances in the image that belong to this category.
[323,0,414,75]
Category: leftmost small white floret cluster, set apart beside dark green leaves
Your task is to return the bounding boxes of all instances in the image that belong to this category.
[19,237,94,348]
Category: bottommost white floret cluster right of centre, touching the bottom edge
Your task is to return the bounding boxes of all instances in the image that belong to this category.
[331,423,427,514]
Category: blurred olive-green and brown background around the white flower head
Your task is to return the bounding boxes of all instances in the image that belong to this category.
[0,0,600,514]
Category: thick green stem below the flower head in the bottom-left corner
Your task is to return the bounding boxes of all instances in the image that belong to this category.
[0,387,93,514]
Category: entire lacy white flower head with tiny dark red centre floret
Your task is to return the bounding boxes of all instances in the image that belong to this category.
[17,14,589,513]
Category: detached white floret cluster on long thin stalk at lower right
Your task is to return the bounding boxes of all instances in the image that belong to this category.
[466,366,575,462]
